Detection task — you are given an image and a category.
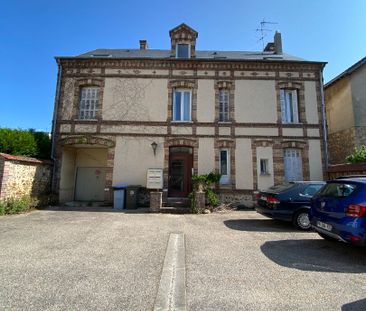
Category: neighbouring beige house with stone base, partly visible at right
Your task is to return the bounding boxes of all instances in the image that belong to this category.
[324,57,366,164]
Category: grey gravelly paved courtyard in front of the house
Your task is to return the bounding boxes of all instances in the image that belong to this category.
[0,208,366,310]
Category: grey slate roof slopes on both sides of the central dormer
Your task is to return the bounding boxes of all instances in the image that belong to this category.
[70,49,305,62]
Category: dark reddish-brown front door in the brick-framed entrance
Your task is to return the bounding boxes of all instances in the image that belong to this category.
[168,147,193,197]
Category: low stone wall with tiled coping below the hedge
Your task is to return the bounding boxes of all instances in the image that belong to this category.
[0,153,52,200]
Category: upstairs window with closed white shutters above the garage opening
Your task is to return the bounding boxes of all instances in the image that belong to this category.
[79,87,99,120]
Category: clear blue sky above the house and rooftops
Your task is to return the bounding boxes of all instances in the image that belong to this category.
[0,0,366,131]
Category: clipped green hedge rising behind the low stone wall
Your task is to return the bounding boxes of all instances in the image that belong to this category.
[0,128,51,159]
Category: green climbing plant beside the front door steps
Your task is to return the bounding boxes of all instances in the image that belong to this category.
[188,172,221,214]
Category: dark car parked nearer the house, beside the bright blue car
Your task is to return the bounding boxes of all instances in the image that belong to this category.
[255,181,325,230]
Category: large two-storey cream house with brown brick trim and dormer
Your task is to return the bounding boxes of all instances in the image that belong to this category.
[53,24,325,206]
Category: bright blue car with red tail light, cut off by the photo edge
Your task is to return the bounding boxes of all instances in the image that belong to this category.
[310,177,366,246]
